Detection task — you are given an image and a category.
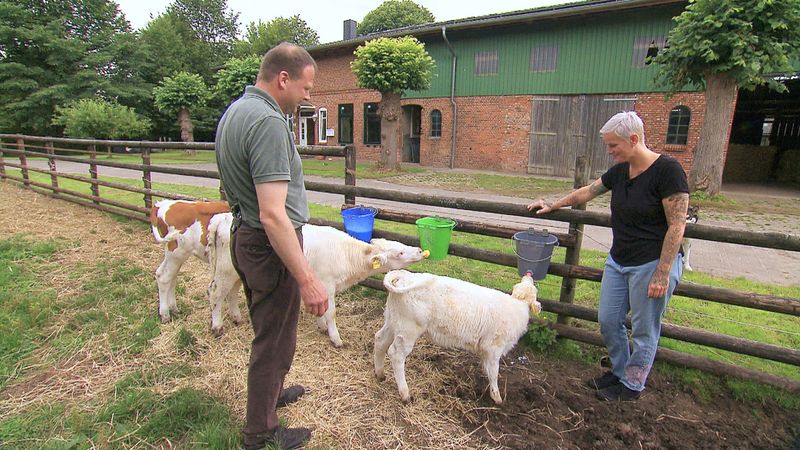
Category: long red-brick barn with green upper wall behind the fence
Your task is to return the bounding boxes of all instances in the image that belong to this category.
[295,0,776,177]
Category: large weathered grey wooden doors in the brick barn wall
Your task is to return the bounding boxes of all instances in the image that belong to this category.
[528,95,636,179]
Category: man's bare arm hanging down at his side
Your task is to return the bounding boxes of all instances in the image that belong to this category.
[256,181,328,316]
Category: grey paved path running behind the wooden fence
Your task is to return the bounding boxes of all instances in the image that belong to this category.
[29,160,800,285]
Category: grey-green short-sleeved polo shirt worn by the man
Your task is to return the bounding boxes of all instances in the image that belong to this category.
[214,86,310,228]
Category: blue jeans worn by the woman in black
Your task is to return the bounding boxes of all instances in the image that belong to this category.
[598,254,683,391]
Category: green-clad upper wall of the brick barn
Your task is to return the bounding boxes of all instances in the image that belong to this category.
[405,5,683,98]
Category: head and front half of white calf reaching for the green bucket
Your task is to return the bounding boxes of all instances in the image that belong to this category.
[303,225,427,347]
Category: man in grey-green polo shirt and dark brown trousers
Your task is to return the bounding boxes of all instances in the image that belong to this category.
[215,42,328,449]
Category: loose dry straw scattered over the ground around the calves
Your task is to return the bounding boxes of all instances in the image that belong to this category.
[0,182,516,449]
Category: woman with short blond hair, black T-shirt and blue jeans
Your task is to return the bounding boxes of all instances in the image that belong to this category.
[528,111,689,401]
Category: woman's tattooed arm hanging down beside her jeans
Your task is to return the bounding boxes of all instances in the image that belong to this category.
[647,192,689,298]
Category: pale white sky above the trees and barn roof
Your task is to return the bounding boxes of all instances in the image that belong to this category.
[116,0,571,44]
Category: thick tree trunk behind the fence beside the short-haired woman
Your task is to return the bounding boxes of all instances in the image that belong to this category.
[689,74,738,195]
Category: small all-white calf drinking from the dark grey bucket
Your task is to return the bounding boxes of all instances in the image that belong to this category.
[374,270,541,404]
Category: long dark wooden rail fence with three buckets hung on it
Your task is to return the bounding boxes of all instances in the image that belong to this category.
[0,134,800,393]
